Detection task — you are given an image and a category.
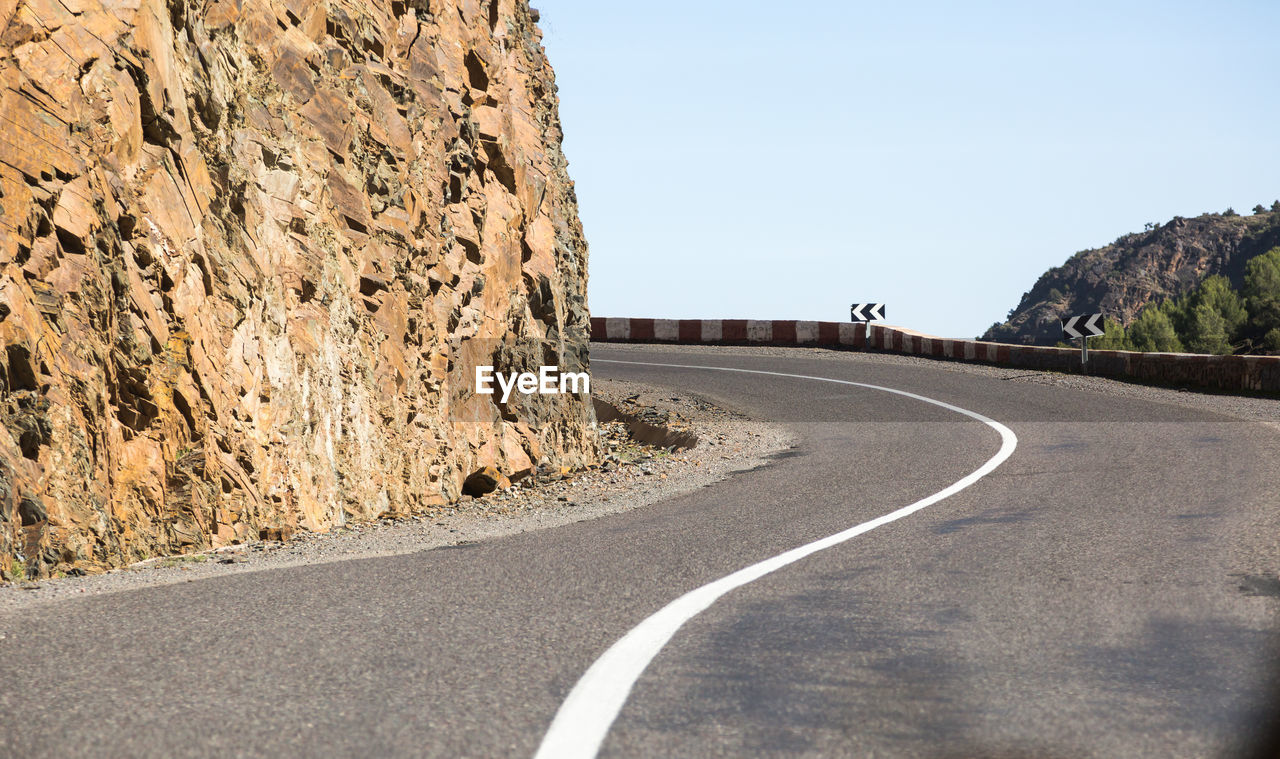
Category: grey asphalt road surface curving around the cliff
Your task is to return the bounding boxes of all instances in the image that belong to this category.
[0,346,1280,758]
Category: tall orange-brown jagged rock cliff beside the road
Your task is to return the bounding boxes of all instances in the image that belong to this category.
[0,0,598,577]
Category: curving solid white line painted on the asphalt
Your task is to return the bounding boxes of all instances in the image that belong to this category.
[535,358,1018,759]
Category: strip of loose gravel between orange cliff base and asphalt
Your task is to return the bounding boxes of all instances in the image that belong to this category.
[0,378,795,612]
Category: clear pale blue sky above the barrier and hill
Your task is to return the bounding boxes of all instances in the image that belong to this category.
[534,0,1280,337]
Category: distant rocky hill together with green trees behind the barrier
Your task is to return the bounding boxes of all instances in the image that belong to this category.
[982,201,1280,353]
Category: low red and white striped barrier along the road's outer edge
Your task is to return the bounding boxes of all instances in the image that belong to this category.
[591,317,1280,393]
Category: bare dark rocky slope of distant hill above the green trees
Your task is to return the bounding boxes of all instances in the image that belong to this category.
[982,211,1280,346]
